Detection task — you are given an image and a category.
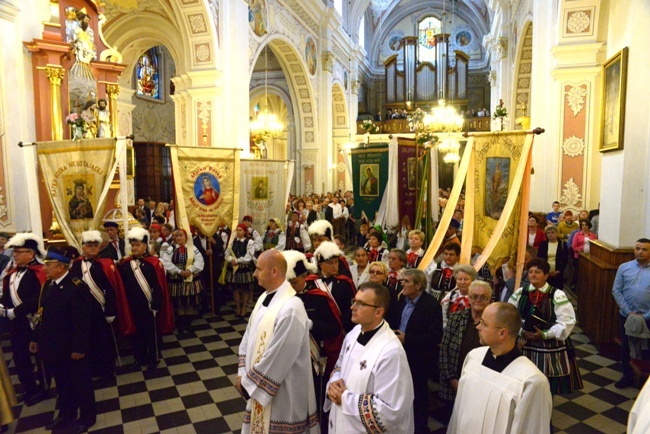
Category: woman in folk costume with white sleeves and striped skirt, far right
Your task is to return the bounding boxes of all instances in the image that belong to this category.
[509,258,582,394]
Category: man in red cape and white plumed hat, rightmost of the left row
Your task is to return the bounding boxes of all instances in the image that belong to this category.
[120,228,174,371]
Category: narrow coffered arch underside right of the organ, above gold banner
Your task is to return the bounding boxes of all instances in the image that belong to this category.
[512,21,533,124]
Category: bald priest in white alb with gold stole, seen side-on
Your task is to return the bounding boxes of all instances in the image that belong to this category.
[235,249,320,434]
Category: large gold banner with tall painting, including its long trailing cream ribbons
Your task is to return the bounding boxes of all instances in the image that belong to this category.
[419,131,534,284]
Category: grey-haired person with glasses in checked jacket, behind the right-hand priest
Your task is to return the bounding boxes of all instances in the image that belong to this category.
[438,280,492,415]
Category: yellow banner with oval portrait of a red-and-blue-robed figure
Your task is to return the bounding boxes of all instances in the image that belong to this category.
[170,145,240,236]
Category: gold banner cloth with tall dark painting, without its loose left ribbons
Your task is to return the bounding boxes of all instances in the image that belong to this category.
[470,132,534,272]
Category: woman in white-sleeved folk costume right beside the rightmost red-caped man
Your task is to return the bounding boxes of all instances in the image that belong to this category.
[160,229,204,333]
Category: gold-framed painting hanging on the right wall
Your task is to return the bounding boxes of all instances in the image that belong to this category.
[600,47,628,152]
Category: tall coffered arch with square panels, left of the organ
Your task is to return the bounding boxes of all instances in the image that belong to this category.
[249,34,318,158]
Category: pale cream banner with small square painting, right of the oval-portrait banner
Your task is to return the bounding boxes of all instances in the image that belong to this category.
[239,159,294,234]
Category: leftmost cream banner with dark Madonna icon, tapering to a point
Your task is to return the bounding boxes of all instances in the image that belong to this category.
[36,138,121,249]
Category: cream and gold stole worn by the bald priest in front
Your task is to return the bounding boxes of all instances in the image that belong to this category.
[246,282,296,434]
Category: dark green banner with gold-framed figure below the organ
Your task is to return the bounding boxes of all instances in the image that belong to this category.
[351,143,388,220]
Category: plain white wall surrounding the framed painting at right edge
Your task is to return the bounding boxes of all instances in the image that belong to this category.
[599,0,650,247]
